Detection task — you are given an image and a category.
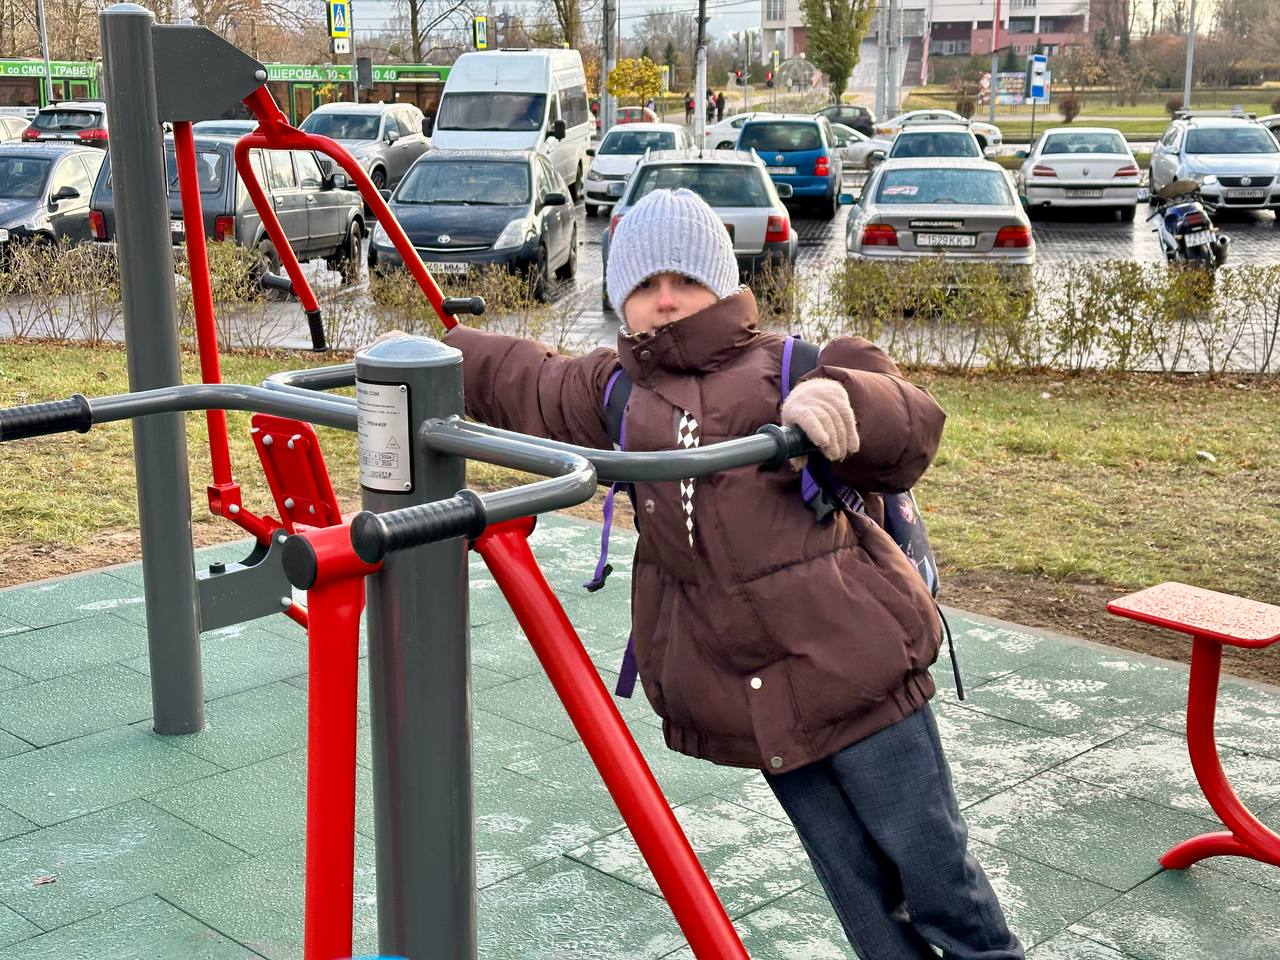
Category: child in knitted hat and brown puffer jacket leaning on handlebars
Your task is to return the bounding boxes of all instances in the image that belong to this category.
[447,189,1023,960]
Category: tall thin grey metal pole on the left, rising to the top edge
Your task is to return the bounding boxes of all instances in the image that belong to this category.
[99,4,205,733]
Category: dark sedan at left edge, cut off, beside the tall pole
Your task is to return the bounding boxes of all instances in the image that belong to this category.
[0,143,105,259]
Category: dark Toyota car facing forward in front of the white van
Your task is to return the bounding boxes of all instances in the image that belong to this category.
[369,150,577,300]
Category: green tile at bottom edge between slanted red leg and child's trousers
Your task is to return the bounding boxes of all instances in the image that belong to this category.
[666,890,856,960]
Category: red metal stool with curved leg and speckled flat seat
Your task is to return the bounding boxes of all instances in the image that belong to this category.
[1107,582,1280,870]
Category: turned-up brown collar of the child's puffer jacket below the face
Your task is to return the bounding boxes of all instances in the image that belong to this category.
[618,288,762,383]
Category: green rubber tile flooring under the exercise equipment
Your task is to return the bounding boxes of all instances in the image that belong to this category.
[0,517,1280,960]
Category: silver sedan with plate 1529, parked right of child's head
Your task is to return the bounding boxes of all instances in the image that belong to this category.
[841,157,1036,266]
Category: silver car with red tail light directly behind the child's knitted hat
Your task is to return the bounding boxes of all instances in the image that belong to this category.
[600,147,799,310]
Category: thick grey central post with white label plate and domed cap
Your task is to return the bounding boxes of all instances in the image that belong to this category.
[356,337,476,960]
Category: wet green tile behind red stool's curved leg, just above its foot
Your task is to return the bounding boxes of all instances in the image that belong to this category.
[1059,727,1280,823]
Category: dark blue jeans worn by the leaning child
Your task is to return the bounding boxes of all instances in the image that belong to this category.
[765,704,1024,960]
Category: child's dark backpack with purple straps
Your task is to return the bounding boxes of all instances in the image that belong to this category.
[582,337,964,700]
